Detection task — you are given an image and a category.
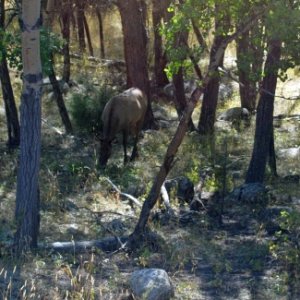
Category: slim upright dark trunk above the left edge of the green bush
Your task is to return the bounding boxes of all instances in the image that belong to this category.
[61,0,71,83]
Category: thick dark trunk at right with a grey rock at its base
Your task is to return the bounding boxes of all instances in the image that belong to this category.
[246,40,281,183]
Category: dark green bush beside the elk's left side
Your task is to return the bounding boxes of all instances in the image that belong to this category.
[70,85,115,134]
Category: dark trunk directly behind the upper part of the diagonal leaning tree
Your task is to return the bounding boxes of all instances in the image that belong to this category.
[198,5,229,134]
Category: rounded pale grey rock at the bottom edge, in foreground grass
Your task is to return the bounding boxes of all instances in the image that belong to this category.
[130,269,174,300]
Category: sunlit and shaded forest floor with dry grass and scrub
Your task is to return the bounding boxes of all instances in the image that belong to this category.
[0,69,300,300]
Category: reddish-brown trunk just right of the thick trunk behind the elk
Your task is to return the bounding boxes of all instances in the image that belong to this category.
[152,0,171,87]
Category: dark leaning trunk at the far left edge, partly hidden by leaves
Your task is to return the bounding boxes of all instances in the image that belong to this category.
[0,0,20,147]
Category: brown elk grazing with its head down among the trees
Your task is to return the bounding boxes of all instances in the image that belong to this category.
[99,88,147,168]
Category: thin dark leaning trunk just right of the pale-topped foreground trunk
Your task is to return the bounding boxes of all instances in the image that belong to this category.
[44,0,73,133]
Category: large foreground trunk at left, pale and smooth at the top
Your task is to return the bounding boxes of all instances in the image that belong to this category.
[14,0,42,253]
